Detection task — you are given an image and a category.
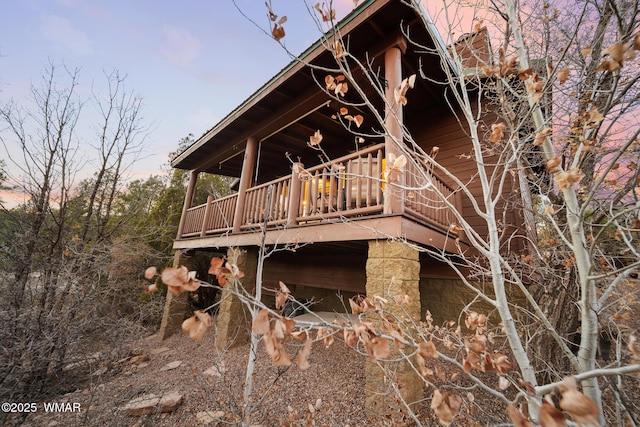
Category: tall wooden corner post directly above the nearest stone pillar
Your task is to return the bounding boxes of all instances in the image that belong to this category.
[384,44,406,214]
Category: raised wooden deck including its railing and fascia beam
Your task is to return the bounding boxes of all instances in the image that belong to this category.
[174,144,461,249]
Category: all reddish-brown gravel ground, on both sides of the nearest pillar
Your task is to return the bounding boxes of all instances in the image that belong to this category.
[22,285,640,427]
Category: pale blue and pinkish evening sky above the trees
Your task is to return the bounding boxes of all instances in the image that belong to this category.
[0,0,353,204]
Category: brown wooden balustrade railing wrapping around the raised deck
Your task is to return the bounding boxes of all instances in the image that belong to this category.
[178,144,460,238]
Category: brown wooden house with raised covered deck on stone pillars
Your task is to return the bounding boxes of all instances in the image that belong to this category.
[159,0,517,414]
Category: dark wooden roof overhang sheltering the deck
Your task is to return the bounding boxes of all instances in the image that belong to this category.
[171,0,456,181]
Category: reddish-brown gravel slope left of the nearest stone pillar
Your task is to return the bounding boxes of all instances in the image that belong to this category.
[23,324,365,427]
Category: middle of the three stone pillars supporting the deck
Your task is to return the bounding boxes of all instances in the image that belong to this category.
[216,247,258,351]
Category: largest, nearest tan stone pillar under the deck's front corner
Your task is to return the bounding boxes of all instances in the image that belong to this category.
[365,241,424,415]
